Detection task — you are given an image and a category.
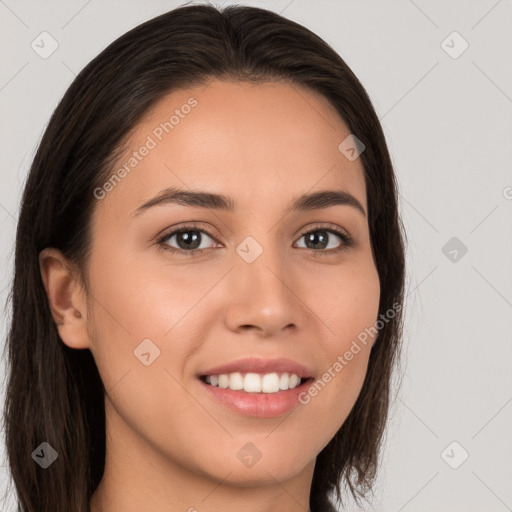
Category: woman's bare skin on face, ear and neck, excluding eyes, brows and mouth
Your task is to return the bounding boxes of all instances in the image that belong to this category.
[40,81,380,512]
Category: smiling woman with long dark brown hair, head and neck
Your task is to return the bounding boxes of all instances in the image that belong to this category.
[4,5,405,512]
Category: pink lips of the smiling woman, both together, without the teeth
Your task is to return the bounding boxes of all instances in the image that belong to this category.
[198,357,314,418]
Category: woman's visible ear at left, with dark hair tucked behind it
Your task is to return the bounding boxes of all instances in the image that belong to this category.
[39,247,90,349]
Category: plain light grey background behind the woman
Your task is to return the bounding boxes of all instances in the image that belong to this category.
[0,0,512,512]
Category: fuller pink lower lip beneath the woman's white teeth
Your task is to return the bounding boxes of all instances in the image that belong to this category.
[199,378,313,418]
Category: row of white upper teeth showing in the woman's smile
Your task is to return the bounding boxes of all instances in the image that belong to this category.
[205,372,301,393]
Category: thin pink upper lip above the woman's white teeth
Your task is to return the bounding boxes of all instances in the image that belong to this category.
[200,357,312,379]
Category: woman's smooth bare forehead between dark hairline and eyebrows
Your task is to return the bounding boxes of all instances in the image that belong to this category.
[94,80,366,221]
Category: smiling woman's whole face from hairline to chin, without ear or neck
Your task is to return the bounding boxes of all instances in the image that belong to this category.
[75,81,380,485]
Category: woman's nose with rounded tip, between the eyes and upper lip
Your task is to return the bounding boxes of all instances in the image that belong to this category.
[226,242,304,337]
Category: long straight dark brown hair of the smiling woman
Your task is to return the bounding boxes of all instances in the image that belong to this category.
[3,5,405,512]
